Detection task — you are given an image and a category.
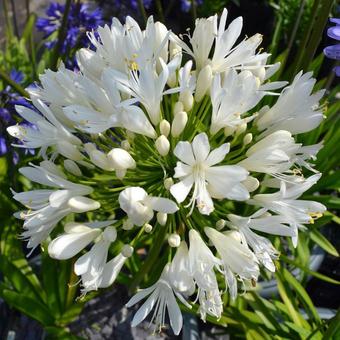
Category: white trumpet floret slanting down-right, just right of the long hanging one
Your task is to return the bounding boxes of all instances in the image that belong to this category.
[204,227,260,299]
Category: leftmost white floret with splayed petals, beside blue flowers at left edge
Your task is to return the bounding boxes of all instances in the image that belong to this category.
[7,99,81,158]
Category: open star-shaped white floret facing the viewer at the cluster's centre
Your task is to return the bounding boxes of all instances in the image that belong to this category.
[170,133,249,215]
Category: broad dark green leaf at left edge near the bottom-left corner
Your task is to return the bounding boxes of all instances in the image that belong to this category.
[2,289,54,326]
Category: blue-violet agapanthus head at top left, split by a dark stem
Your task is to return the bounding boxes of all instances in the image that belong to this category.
[36,2,104,53]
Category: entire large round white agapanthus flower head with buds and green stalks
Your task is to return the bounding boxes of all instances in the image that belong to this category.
[8,10,326,334]
